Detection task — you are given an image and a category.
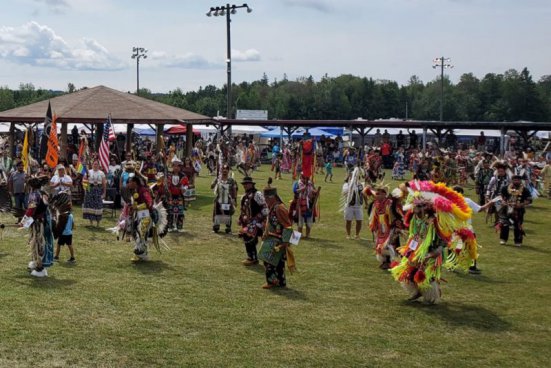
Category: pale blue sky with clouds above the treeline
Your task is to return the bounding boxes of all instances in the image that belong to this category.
[0,0,551,92]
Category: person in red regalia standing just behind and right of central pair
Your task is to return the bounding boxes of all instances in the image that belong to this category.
[293,173,319,238]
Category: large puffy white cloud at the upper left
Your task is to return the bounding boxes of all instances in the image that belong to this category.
[0,22,127,70]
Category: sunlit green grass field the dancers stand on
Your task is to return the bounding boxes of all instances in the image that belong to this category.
[0,166,551,367]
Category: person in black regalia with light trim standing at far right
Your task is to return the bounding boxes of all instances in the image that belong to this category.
[497,175,532,247]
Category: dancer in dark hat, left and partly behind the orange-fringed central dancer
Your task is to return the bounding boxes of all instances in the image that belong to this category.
[238,176,268,266]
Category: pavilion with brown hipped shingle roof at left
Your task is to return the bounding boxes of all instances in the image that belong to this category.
[0,86,213,159]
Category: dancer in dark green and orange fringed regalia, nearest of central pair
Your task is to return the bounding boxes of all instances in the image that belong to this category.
[258,187,295,289]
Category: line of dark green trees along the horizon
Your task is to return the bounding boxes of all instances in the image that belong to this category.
[0,68,551,122]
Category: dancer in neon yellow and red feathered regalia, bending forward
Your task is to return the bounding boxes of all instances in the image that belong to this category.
[391,181,478,304]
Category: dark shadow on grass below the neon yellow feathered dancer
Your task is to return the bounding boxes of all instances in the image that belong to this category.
[407,302,511,332]
